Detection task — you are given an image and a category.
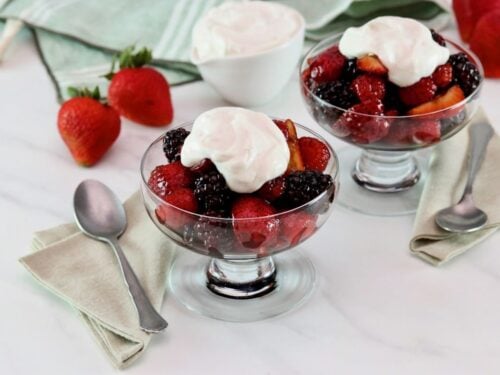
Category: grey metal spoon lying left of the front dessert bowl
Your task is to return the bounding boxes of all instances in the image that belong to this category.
[73,180,167,333]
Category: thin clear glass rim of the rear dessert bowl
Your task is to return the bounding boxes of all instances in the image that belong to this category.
[299,33,484,120]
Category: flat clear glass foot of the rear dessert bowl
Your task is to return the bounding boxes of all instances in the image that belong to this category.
[338,147,428,216]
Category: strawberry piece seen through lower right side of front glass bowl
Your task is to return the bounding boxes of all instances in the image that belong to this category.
[280,211,317,246]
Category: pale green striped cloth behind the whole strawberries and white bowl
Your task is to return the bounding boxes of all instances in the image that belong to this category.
[0,0,448,101]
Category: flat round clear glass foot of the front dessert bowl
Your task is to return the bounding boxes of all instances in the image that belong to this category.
[169,249,316,322]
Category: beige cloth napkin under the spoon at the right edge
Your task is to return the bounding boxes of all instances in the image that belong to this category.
[410,108,500,265]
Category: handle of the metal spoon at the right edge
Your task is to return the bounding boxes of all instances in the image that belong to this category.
[463,122,494,197]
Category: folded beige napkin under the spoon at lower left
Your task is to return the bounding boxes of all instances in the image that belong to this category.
[20,192,175,368]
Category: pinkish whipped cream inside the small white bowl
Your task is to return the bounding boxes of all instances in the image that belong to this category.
[191,1,305,64]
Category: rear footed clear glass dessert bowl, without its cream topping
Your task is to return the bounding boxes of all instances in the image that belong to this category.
[300,35,484,216]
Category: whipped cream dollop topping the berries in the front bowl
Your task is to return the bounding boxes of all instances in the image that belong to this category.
[181,107,290,193]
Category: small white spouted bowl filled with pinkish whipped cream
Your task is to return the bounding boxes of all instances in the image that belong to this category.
[191,1,305,106]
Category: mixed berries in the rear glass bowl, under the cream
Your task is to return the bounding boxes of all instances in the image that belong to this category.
[301,30,482,148]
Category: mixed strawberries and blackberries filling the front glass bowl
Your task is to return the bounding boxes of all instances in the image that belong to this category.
[148,120,335,257]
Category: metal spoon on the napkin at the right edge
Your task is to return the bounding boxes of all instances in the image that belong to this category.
[436,122,494,233]
